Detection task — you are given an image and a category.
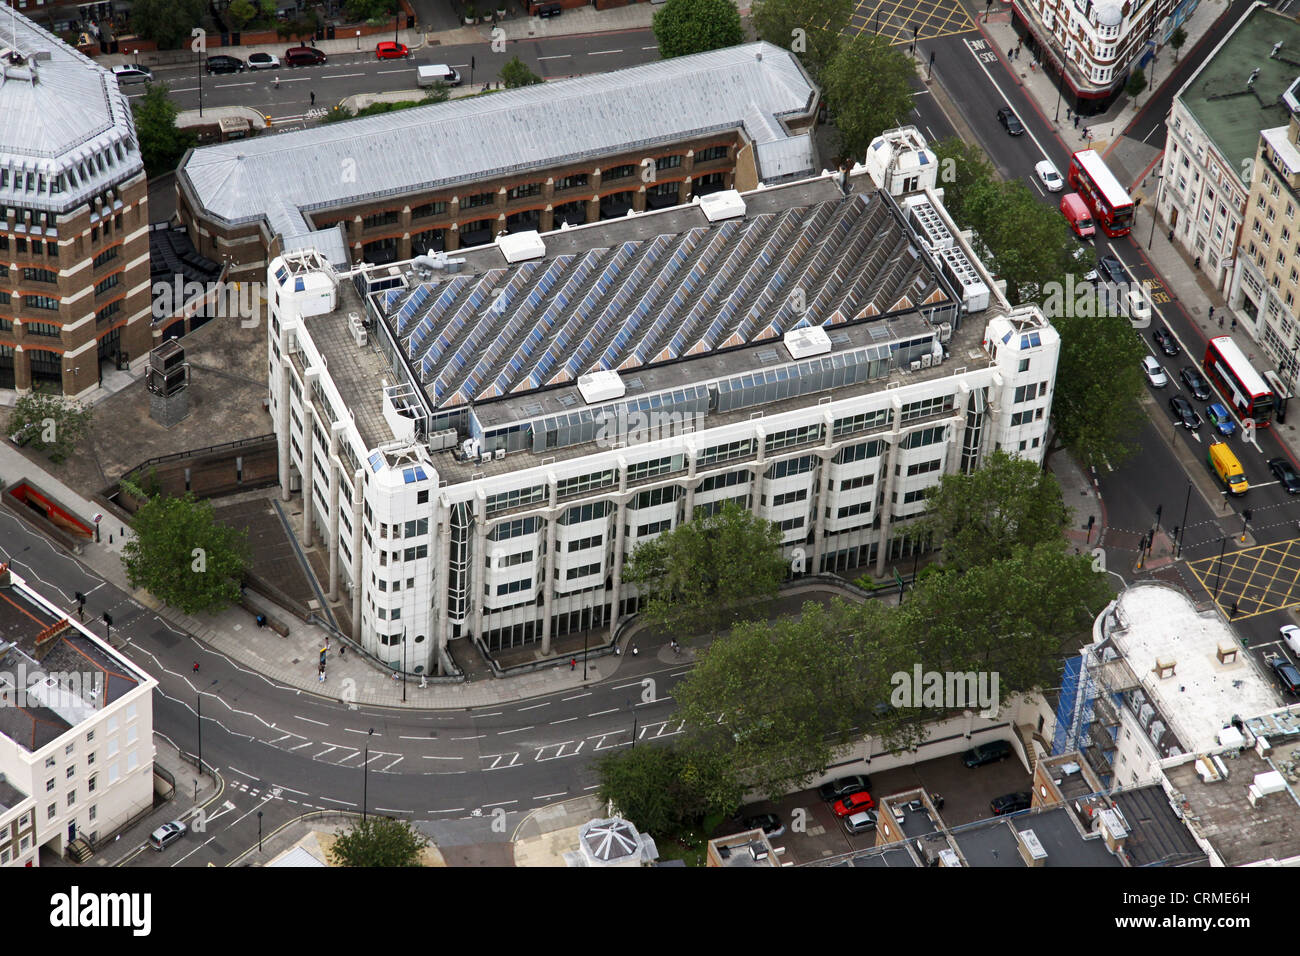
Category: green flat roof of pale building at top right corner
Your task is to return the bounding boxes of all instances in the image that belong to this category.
[1179,4,1300,185]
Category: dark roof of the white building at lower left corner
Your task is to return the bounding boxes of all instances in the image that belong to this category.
[0,580,143,752]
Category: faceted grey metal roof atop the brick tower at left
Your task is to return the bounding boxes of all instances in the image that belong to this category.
[0,10,143,211]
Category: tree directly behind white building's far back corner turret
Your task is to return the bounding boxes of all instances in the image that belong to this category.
[820,34,917,159]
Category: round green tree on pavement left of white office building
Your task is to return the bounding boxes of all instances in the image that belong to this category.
[122,481,248,614]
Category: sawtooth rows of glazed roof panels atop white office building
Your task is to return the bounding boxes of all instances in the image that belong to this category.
[376,194,948,407]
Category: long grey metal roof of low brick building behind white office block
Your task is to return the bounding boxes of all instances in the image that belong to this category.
[178,43,816,256]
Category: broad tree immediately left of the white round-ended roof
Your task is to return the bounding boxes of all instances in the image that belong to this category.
[893,541,1114,700]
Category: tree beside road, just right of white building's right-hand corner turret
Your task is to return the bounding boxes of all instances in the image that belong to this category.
[1047,308,1147,466]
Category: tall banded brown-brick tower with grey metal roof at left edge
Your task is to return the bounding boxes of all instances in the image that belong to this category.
[0,6,151,395]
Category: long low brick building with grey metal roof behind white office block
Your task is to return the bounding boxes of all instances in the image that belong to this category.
[177,43,819,278]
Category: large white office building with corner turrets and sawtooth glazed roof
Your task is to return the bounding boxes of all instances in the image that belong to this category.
[268,153,1060,674]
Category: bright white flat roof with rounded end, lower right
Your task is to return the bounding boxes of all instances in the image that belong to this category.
[1109,583,1284,752]
